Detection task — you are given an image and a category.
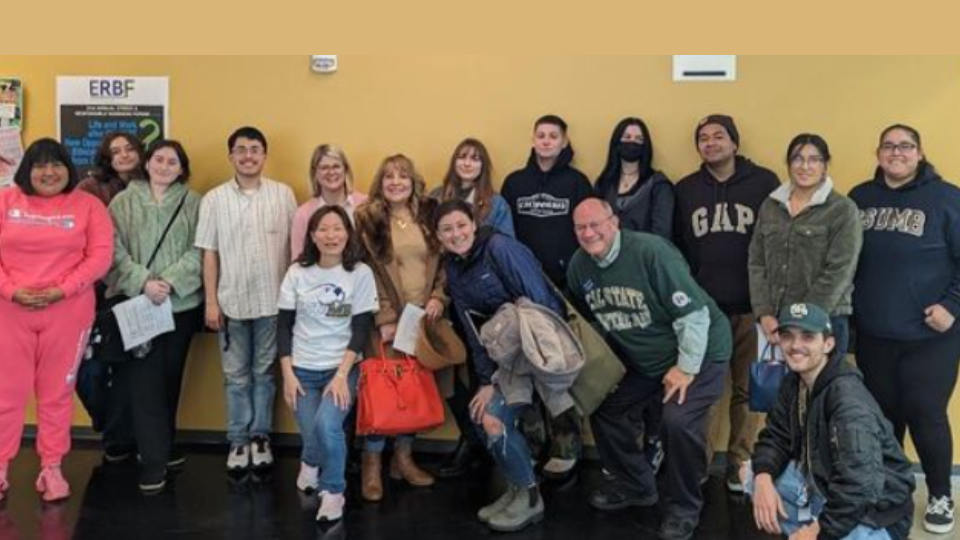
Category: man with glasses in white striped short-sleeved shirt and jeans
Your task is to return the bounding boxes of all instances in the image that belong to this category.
[196,127,297,472]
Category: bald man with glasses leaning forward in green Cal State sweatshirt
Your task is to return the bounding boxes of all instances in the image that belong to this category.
[567,199,732,540]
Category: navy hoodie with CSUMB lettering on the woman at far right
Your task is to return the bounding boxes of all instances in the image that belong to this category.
[850,165,960,341]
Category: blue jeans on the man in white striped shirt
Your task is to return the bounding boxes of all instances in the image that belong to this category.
[220,317,277,445]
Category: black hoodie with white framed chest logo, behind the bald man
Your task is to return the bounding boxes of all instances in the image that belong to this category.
[500,146,593,290]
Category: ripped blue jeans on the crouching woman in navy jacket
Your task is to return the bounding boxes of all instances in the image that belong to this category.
[474,389,537,488]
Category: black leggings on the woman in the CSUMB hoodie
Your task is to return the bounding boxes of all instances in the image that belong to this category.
[857,331,960,497]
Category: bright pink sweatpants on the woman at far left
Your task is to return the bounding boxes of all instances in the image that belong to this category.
[0,290,94,465]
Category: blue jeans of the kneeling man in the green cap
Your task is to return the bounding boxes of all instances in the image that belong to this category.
[743,461,890,540]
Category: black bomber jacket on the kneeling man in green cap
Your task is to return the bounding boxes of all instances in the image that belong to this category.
[753,358,915,540]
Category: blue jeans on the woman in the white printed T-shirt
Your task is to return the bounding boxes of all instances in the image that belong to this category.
[293,367,359,493]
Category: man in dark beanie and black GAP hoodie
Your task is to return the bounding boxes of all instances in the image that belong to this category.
[675,114,780,493]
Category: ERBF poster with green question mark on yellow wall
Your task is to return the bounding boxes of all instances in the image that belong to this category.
[57,77,170,177]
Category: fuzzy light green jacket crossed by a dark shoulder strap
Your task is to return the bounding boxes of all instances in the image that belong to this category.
[105,180,203,313]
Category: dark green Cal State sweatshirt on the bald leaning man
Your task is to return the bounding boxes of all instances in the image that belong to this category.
[567,231,733,378]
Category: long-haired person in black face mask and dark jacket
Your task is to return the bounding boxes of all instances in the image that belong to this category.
[595,117,674,241]
